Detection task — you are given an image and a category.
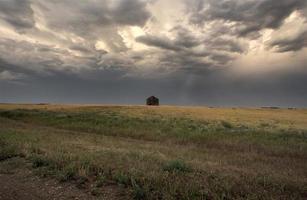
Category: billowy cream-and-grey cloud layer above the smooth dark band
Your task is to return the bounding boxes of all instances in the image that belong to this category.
[0,0,307,106]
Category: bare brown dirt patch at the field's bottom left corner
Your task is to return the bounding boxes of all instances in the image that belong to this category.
[0,158,127,200]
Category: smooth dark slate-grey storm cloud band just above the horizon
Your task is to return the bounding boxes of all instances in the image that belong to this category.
[0,64,307,107]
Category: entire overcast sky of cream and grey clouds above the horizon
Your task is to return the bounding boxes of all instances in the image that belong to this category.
[0,0,307,107]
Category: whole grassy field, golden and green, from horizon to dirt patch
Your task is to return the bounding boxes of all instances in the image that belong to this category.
[0,104,307,199]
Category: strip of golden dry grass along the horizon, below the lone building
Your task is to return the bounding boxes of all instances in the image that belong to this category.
[0,104,307,129]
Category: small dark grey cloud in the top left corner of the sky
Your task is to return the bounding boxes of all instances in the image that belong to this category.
[0,0,35,32]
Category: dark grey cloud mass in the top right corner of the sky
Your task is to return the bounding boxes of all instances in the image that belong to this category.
[190,0,306,36]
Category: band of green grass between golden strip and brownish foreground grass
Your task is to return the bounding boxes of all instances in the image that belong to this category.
[0,109,307,144]
